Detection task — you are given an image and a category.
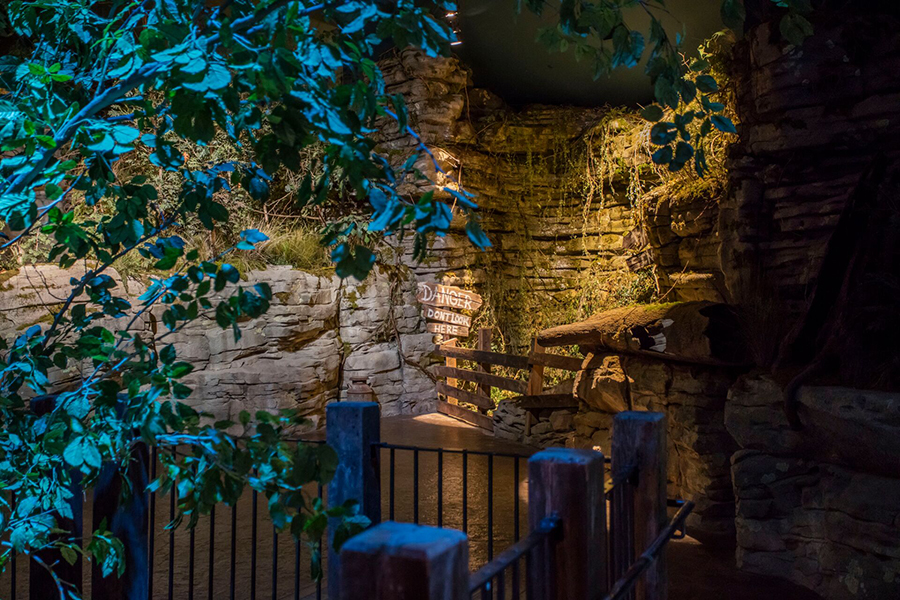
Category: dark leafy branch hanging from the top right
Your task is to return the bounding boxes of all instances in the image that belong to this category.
[517,0,812,177]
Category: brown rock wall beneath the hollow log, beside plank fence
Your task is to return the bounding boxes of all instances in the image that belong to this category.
[494,354,737,545]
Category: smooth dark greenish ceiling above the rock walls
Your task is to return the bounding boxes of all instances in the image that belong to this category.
[455,0,724,106]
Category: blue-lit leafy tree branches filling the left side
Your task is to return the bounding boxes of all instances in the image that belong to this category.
[0,0,478,597]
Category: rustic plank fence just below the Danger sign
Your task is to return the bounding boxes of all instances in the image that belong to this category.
[434,328,583,435]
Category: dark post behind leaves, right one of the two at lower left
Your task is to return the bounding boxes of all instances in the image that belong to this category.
[91,443,149,600]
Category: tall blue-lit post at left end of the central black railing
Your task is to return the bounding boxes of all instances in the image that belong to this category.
[325,402,381,598]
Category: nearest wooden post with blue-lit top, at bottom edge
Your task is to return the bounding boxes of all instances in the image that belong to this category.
[340,521,469,600]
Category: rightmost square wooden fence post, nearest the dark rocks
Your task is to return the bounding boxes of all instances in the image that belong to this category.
[612,411,668,600]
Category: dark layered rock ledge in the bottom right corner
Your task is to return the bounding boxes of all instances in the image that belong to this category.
[726,377,900,600]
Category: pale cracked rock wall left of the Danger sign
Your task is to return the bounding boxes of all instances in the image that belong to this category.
[0,265,435,427]
